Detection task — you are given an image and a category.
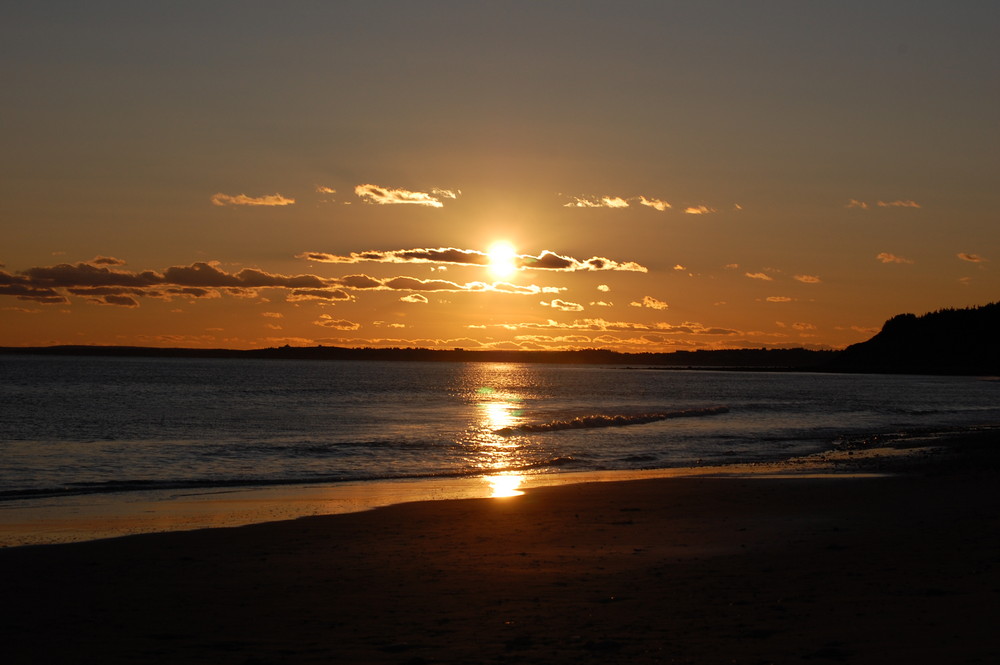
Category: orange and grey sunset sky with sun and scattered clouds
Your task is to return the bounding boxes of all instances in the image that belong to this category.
[0,0,1000,352]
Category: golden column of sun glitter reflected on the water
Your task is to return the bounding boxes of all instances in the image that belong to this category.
[466,363,530,498]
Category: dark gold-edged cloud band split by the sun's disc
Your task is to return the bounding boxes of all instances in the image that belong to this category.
[295,247,647,272]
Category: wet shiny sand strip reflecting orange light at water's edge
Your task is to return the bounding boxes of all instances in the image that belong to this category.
[0,428,990,549]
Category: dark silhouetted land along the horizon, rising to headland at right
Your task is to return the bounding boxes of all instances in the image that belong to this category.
[0,303,1000,375]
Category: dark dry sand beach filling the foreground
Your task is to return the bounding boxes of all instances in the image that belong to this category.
[0,432,1000,665]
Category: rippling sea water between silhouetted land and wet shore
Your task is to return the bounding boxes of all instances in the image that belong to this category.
[0,355,1000,502]
